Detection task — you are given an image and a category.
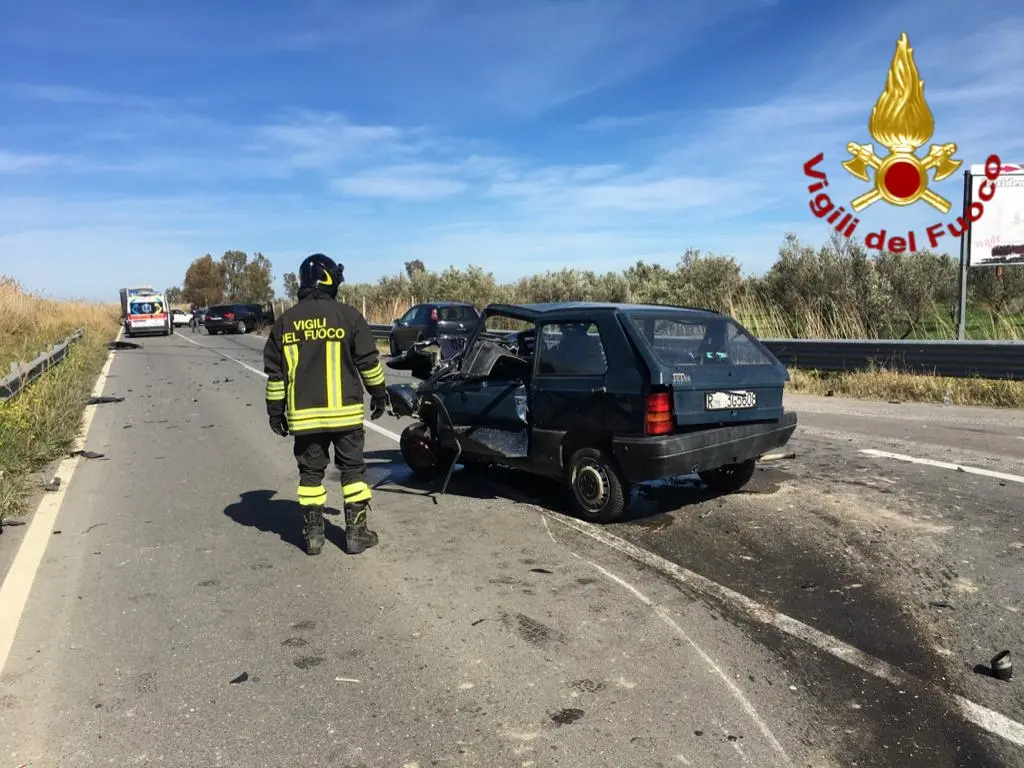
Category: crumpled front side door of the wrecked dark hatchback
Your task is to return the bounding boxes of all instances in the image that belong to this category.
[438,340,531,461]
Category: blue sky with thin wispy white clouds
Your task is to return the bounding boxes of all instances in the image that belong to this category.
[0,0,1024,299]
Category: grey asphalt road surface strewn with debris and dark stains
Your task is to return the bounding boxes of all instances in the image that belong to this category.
[0,331,1024,768]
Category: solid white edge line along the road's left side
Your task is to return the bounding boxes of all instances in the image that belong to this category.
[0,329,124,675]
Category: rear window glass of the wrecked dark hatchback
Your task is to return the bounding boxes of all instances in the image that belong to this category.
[630,314,775,368]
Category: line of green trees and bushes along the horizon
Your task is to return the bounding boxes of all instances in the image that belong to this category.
[167,234,1024,338]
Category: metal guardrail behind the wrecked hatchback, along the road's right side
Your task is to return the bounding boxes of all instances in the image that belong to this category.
[371,326,1024,381]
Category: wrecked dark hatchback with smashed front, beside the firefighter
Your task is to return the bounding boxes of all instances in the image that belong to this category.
[387,302,797,522]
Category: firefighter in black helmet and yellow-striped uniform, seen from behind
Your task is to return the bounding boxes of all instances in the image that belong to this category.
[263,253,387,555]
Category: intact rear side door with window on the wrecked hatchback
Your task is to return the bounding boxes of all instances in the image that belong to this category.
[530,318,608,468]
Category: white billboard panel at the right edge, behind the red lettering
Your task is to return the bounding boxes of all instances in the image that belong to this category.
[964,163,1024,266]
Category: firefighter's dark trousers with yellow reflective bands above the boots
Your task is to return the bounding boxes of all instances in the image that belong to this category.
[294,427,372,507]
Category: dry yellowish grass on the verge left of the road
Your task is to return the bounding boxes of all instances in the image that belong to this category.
[0,276,120,519]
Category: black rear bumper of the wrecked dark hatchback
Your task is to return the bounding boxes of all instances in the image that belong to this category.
[611,411,797,483]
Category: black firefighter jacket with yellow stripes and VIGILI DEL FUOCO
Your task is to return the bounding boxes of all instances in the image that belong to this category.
[263,293,384,434]
